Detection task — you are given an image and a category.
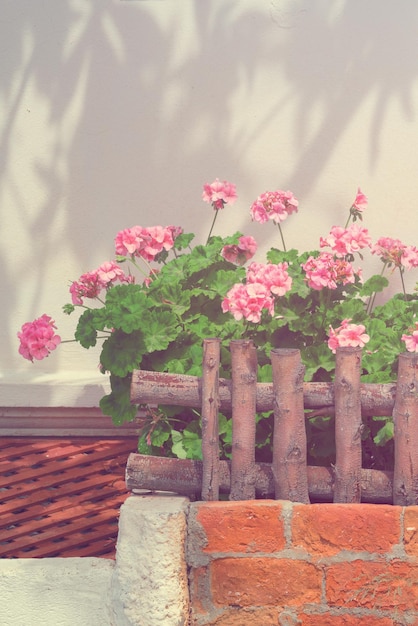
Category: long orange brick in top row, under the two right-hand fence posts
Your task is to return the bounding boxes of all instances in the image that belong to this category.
[292,504,402,556]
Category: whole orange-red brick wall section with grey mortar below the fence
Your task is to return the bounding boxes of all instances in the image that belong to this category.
[187,500,418,626]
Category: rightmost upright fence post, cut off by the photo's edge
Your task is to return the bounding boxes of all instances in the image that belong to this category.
[393,352,418,506]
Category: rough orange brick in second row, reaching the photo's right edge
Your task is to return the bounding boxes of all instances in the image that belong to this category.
[326,560,418,611]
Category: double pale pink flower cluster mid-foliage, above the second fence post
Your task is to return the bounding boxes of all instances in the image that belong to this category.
[222,262,292,324]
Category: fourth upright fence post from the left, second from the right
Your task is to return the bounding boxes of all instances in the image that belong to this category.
[334,347,362,503]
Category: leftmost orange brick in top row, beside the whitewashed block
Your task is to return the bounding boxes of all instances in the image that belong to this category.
[196,500,286,553]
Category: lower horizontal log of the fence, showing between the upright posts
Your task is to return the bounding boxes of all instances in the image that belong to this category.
[126,453,392,504]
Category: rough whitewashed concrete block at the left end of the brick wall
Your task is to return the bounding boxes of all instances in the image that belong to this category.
[112,494,189,626]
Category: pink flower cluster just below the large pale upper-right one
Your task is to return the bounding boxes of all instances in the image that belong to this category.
[302,252,361,291]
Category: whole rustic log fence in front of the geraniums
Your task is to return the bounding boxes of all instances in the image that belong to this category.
[127,339,418,506]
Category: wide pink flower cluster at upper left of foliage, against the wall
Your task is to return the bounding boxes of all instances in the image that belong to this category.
[115,226,183,261]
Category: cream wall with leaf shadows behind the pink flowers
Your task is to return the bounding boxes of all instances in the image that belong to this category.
[0,0,418,405]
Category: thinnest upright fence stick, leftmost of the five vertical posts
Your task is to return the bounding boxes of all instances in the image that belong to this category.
[201,339,221,500]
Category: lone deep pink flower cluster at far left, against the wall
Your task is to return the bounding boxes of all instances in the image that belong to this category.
[17,314,61,362]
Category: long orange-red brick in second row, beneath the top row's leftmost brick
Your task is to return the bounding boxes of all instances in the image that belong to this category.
[211,557,322,606]
